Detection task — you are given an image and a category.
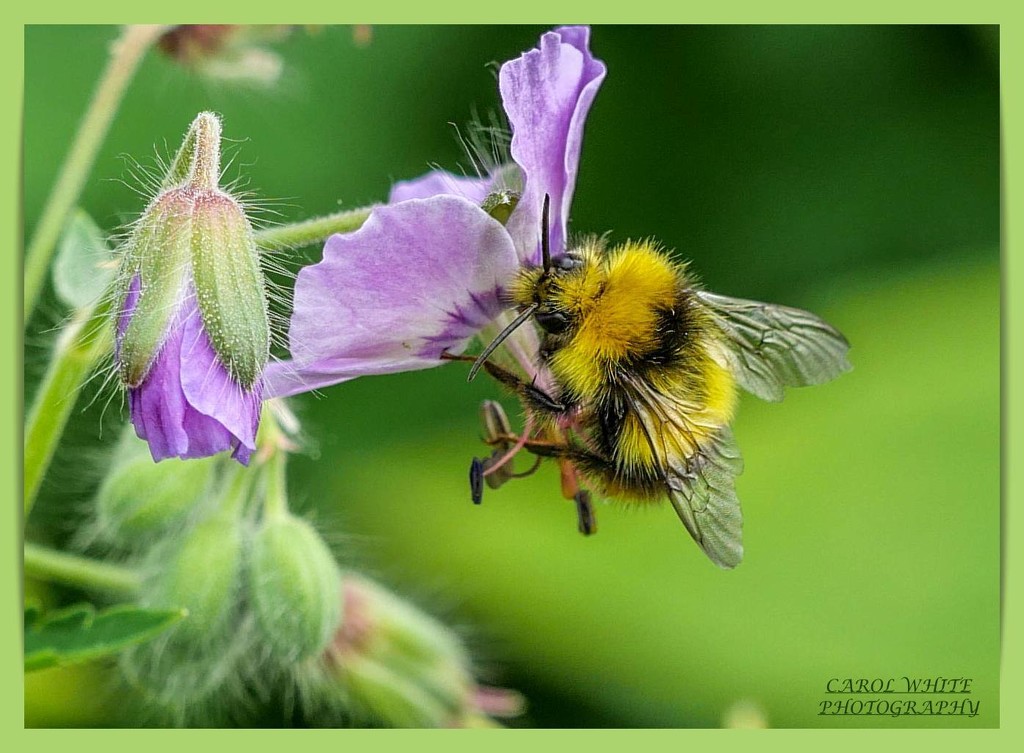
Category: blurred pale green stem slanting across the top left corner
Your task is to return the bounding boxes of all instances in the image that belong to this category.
[24,25,166,322]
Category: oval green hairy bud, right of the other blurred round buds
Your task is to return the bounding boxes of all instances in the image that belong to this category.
[249,512,342,663]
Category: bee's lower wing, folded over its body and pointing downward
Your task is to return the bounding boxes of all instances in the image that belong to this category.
[624,375,743,569]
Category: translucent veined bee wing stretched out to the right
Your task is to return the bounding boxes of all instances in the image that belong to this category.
[697,291,851,402]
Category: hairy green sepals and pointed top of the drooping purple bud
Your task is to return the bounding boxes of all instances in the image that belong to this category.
[116,112,270,387]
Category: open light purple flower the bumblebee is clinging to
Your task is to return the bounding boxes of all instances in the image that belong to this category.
[266,27,605,395]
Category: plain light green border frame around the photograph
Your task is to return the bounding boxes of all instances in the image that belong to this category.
[6,0,1024,751]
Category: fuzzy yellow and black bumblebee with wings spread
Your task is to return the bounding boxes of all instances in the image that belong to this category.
[457,197,851,569]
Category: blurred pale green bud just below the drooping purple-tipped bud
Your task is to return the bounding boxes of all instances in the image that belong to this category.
[96,431,216,546]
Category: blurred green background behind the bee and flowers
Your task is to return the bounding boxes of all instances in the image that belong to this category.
[24,27,999,727]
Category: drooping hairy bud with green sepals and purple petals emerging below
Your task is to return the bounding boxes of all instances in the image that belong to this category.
[115,113,270,463]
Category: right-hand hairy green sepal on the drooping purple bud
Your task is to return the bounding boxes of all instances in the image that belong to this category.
[191,192,270,389]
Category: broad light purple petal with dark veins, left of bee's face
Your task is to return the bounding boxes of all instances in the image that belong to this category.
[268,196,518,396]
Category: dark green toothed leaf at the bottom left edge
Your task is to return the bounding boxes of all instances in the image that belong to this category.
[25,603,186,671]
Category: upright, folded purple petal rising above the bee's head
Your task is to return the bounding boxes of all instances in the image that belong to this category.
[498,27,606,264]
